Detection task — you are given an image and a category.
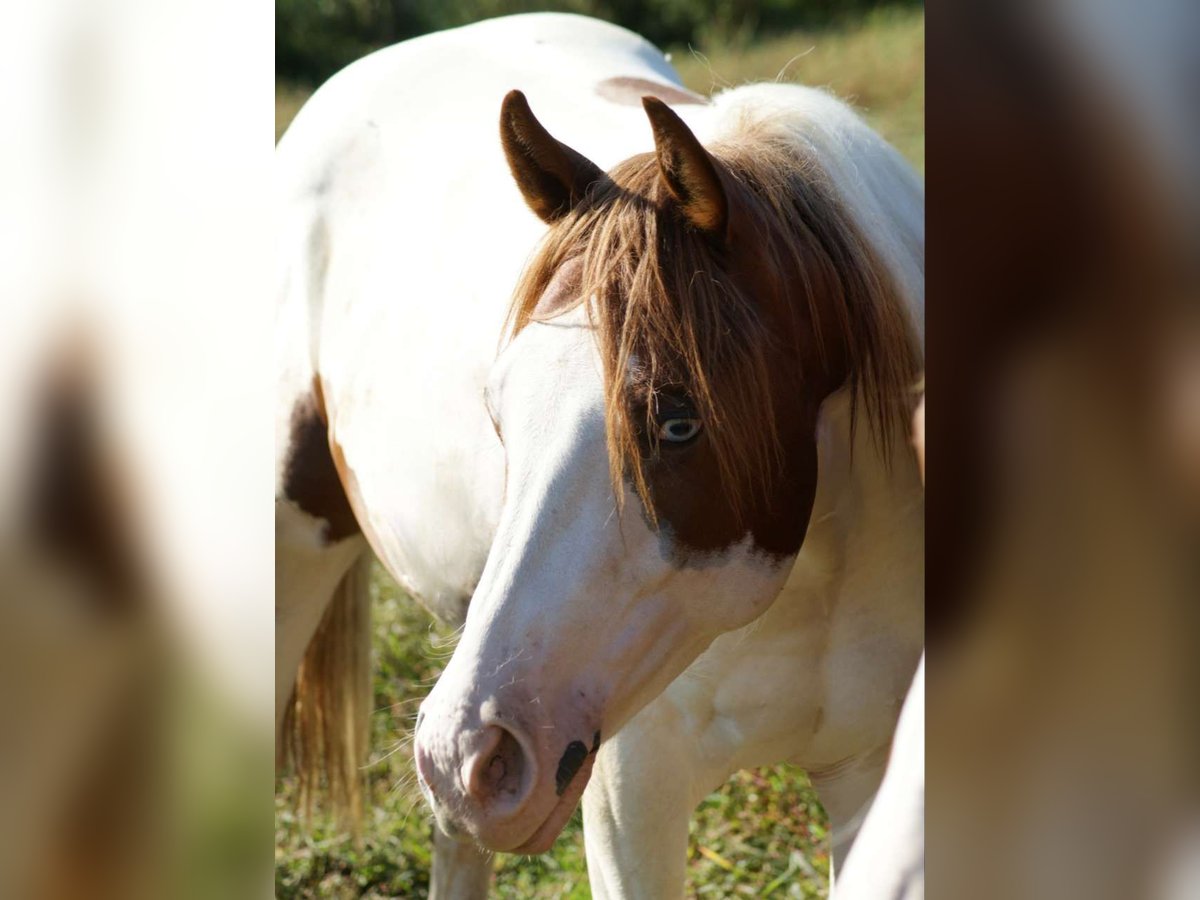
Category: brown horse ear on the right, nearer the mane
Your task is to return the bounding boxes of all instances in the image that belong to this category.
[642,97,730,239]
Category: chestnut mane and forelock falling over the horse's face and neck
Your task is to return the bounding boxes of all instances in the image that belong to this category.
[509,126,919,517]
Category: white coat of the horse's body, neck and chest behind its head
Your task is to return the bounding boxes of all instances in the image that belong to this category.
[277,13,924,898]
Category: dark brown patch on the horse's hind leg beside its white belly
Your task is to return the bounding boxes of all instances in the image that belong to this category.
[283,378,361,541]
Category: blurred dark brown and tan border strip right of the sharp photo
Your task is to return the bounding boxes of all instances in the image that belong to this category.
[926,1,1200,900]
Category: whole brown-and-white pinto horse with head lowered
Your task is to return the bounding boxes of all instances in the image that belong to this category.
[276,13,924,898]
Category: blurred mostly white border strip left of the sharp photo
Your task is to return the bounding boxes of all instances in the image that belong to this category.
[0,0,274,900]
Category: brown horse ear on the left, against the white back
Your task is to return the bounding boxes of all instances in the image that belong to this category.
[500,91,604,223]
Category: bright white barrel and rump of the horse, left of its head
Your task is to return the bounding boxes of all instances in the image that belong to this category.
[276,13,696,618]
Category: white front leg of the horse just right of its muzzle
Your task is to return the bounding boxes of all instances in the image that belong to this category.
[583,695,732,900]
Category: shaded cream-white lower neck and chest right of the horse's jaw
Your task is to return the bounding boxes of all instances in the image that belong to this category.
[668,389,924,776]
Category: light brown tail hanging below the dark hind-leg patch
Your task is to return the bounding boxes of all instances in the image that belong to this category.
[280,553,372,830]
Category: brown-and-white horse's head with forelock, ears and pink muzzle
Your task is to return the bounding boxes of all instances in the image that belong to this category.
[415,91,916,853]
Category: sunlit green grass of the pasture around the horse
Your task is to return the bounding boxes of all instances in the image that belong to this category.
[275,7,925,900]
